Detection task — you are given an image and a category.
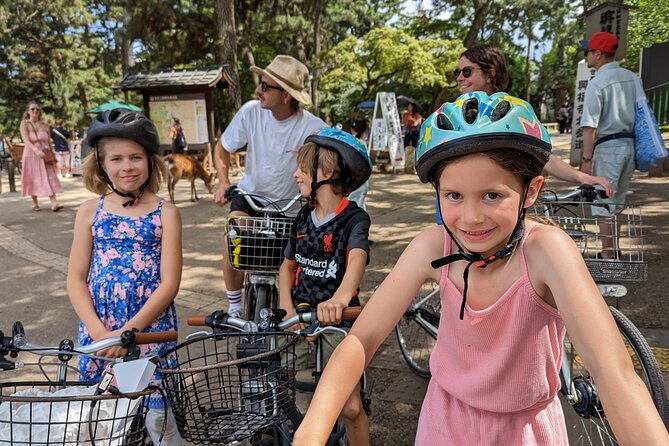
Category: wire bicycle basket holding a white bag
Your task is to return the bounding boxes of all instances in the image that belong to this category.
[0,381,155,446]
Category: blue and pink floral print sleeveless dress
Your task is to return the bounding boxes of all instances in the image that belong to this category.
[79,196,177,408]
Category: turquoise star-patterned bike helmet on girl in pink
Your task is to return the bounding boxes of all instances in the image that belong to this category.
[415,91,551,183]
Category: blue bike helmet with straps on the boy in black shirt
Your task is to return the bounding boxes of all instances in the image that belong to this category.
[304,127,372,199]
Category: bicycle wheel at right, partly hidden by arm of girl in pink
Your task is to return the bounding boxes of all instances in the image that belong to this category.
[560,307,667,445]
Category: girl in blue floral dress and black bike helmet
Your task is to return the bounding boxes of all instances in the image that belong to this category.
[67,109,182,445]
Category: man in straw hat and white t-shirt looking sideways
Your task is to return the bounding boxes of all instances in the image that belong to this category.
[214,55,326,315]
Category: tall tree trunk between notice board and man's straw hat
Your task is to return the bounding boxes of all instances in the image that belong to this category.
[214,0,242,109]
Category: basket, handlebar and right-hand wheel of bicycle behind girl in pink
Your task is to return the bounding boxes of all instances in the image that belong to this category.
[535,185,669,444]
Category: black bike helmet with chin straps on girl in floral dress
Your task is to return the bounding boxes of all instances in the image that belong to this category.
[86,108,160,207]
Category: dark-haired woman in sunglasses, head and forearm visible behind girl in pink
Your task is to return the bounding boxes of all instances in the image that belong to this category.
[454,45,613,196]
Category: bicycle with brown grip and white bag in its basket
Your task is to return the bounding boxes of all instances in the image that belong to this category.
[0,322,177,446]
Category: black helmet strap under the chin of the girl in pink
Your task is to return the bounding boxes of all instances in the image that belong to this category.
[431,183,528,320]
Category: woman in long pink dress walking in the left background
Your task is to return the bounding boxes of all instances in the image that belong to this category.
[20,101,63,212]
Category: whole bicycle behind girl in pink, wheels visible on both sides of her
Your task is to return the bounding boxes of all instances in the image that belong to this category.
[395,185,669,445]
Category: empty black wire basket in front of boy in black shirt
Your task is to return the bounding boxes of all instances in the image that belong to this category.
[160,332,299,444]
